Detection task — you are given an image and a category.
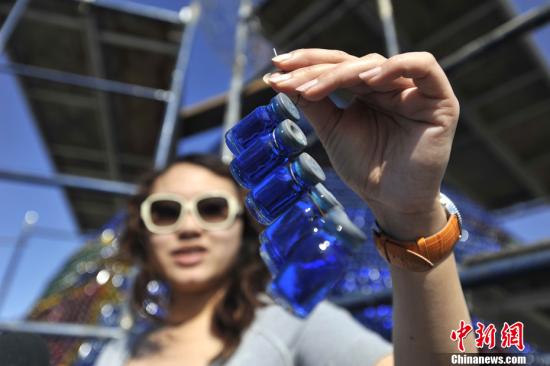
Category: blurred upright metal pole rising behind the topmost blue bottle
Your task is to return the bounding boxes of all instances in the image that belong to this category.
[220,0,252,163]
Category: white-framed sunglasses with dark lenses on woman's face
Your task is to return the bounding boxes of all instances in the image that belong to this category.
[140,192,243,234]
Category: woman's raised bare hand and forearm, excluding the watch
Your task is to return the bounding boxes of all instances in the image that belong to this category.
[265,49,475,365]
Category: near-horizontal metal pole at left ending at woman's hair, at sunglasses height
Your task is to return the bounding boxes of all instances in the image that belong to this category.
[0,170,137,196]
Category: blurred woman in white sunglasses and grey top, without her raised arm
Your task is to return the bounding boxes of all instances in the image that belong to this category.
[96,155,390,366]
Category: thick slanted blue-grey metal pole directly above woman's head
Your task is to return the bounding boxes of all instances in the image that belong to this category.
[155,0,200,170]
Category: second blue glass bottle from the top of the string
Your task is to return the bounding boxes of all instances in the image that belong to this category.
[229,119,307,189]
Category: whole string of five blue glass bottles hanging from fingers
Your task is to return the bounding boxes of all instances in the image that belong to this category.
[225,94,366,317]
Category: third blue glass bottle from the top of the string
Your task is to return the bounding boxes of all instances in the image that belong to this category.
[245,153,325,225]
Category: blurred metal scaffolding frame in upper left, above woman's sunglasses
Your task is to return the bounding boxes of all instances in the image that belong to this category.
[0,0,200,195]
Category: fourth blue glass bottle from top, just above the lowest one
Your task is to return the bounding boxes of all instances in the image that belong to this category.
[260,183,342,276]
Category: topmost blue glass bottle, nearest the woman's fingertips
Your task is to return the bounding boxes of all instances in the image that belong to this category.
[225,93,300,156]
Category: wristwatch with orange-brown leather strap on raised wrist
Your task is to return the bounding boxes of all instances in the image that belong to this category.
[373,193,462,272]
